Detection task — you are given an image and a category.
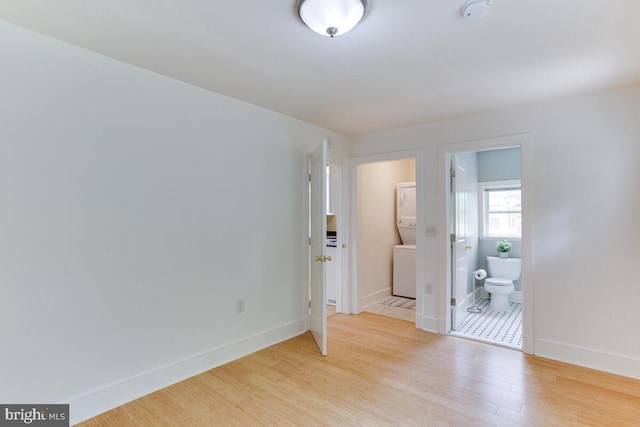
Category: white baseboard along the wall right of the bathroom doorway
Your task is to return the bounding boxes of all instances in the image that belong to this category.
[534,339,640,379]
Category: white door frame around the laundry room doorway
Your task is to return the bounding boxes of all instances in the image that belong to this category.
[348,150,425,329]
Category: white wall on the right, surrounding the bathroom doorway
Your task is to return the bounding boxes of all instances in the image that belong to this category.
[353,86,640,378]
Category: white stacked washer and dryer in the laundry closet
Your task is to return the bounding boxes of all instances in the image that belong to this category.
[393,182,416,298]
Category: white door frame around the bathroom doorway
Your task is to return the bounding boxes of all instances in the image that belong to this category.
[438,133,534,354]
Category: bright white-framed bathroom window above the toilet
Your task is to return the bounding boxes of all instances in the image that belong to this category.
[479,180,522,238]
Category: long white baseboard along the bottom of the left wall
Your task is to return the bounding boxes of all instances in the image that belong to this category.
[67,319,306,425]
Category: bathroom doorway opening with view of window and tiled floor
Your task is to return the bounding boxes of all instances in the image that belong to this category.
[444,137,530,350]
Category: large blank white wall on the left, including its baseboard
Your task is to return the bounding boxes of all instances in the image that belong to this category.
[0,21,348,422]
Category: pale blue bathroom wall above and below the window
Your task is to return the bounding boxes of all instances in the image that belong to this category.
[478,147,522,291]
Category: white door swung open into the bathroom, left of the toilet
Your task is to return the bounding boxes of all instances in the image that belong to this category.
[451,155,471,330]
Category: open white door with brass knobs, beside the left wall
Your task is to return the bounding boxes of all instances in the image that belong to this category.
[309,140,330,356]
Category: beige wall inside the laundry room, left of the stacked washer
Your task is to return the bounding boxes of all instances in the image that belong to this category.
[356,158,416,308]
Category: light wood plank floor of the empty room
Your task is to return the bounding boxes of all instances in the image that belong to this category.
[81,313,640,427]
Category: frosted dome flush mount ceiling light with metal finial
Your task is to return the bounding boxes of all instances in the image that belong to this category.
[298,0,367,37]
